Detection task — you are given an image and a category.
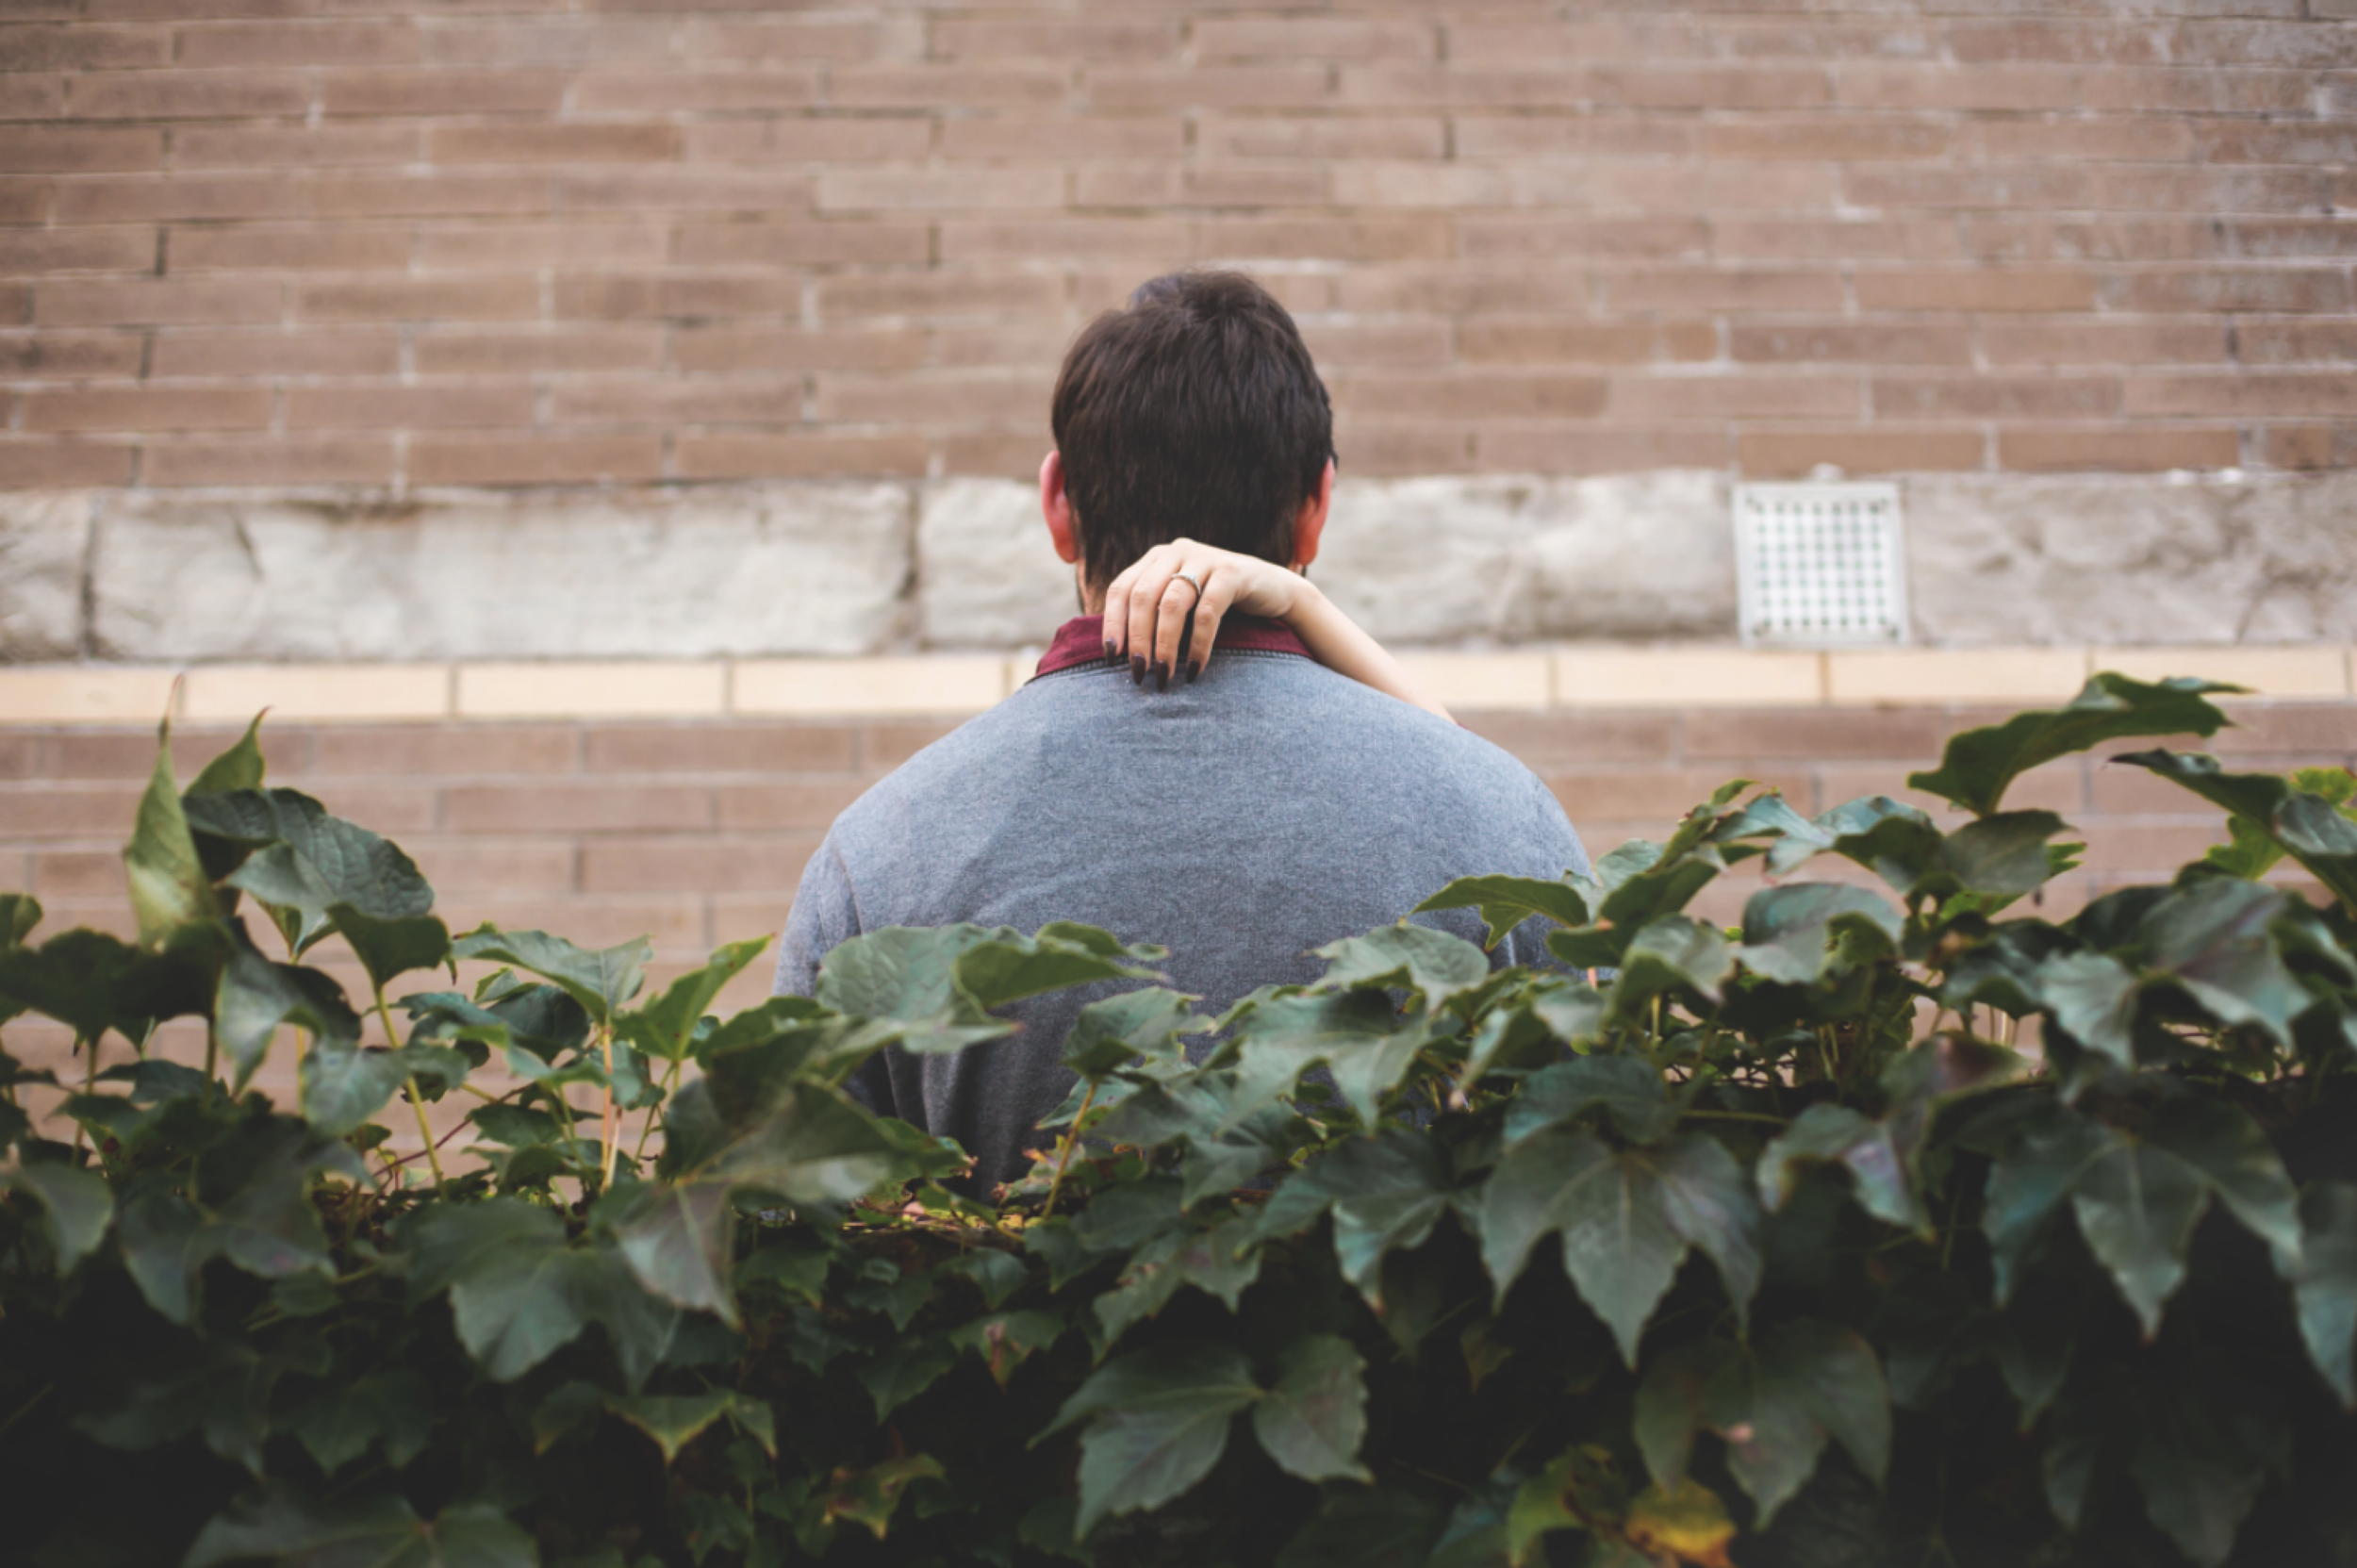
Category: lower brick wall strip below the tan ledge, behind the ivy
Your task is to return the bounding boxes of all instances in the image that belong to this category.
[0,701,2357,1131]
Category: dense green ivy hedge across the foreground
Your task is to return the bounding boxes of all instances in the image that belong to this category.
[0,674,2357,1568]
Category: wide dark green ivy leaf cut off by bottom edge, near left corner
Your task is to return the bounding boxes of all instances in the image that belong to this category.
[182,1493,540,1568]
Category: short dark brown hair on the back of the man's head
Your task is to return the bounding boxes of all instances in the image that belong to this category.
[1049,272,1334,587]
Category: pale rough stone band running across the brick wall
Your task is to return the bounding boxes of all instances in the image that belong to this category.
[0,471,2357,665]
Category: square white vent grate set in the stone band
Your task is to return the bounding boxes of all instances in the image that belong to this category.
[1735,484,1907,649]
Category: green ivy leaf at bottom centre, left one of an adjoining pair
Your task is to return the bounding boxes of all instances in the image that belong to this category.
[1035,1339,1261,1537]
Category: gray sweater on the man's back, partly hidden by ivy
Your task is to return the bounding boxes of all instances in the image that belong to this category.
[776,651,1589,1191]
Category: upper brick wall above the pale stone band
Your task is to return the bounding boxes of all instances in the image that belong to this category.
[0,0,2357,486]
